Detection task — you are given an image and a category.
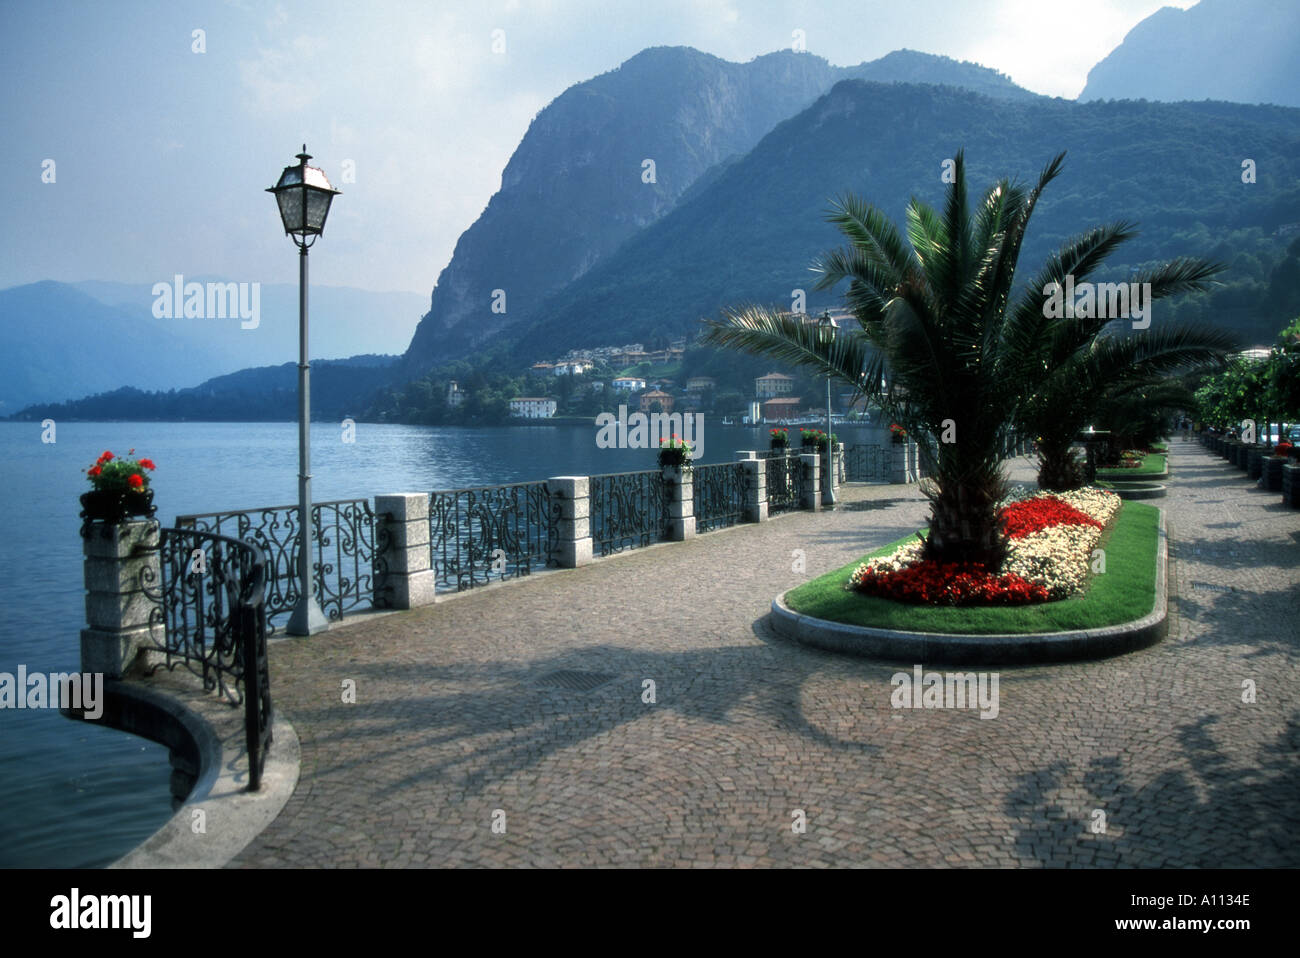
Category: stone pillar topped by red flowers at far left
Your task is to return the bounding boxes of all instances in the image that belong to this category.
[81,519,166,679]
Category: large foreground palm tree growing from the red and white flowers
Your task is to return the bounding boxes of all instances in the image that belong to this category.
[705,152,1216,569]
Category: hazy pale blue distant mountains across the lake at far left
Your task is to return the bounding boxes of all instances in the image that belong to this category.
[0,277,423,416]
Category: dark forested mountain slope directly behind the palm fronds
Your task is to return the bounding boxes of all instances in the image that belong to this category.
[512,81,1300,364]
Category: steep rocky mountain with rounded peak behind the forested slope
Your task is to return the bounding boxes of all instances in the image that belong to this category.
[403,47,1037,376]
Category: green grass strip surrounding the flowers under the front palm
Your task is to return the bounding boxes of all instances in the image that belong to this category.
[785,502,1160,636]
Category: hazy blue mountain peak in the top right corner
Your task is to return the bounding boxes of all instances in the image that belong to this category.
[1079,0,1300,107]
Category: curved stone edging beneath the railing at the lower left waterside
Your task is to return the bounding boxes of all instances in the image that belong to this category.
[76,672,302,868]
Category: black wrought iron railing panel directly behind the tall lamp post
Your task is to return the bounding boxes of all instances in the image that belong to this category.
[176,499,387,632]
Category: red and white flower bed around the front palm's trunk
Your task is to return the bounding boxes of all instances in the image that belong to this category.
[849,489,1121,606]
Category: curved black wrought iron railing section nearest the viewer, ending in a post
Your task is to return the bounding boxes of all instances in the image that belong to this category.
[140,528,273,792]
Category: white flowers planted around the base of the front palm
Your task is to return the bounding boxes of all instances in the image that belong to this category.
[849,489,1121,599]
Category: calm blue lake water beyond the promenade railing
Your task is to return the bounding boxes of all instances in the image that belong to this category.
[0,422,884,867]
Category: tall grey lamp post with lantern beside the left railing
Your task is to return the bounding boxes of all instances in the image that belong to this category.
[267,143,339,636]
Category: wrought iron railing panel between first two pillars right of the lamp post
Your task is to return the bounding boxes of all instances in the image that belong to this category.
[429,482,560,591]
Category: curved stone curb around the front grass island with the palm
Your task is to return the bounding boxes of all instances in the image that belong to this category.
[771,510,1169,666]
